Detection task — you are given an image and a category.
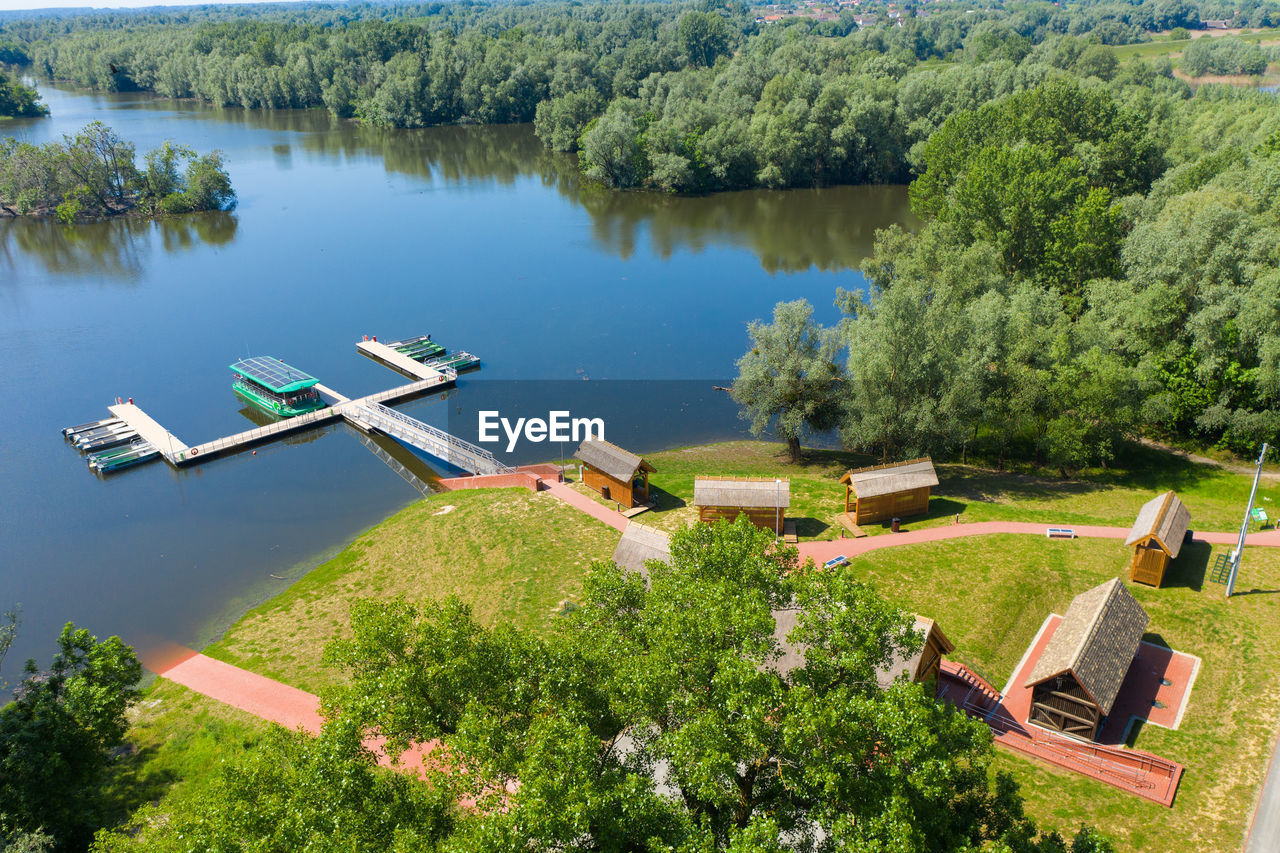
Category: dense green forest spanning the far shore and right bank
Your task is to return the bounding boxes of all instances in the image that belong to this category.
[0,0,1280,458]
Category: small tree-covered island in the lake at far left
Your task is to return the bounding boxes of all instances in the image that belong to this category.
[0,122,236,223]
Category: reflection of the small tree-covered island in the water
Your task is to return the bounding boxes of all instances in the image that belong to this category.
[0,210,238,283]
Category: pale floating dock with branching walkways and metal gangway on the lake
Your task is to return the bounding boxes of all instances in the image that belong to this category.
[63,336,499,479]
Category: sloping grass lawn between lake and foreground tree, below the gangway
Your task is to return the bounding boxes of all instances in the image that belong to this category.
[205,489,618,692]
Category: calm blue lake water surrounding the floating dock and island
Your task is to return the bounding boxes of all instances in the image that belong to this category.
[0,85,910,681]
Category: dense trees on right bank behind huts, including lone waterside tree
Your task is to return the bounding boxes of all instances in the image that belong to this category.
[735,73,1280,474]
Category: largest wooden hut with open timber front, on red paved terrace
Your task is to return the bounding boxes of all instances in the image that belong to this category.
[1027,578,1149,740]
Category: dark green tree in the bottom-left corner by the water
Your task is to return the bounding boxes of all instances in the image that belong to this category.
[0,622,142,849]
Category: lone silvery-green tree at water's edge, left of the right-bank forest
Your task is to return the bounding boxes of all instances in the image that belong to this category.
[731,300,841,462]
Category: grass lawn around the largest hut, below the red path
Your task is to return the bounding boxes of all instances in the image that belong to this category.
[849,535,1280,853]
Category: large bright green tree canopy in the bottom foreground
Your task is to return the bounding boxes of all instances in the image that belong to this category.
[94,519,1108,853]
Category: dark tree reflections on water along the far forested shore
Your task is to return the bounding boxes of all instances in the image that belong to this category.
[15,85,918,273]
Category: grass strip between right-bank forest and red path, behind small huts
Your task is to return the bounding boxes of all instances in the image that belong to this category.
[614,441,1280,539]
